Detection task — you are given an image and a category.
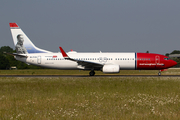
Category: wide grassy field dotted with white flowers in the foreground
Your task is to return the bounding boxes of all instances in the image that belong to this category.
[0,77,180,120]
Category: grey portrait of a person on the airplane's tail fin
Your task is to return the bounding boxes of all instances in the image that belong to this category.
[16,34,28,54]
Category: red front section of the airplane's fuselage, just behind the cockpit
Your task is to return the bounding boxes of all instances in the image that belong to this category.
[136,53,171,70]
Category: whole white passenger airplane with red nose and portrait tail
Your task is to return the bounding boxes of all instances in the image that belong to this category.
[9,23,177,76]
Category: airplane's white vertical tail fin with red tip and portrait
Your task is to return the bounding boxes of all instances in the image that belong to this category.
[9,23,51,54]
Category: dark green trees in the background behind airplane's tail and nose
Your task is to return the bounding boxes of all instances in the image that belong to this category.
[0,46,180,70]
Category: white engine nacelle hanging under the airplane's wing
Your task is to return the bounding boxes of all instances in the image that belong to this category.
[102,65,120,73]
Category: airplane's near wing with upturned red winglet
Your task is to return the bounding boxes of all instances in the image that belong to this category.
[59,47,103,68]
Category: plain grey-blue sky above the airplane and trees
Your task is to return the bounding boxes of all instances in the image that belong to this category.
[0,0,180,54]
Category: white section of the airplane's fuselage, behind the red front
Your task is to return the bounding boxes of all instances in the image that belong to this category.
[16,52,136,70]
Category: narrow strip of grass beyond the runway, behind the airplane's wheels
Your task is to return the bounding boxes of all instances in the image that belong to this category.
[0,69,180,75]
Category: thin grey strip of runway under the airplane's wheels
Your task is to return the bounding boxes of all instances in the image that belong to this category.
[0,75,180,78]
